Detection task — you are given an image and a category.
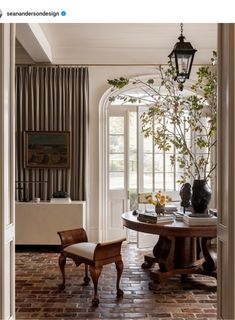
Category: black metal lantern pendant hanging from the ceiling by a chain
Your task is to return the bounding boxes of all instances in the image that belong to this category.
[168,23,197,90]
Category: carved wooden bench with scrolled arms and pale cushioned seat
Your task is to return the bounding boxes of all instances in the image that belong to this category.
[58,228,125,306]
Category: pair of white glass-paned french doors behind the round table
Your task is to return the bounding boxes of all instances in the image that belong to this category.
[106,105,182,242]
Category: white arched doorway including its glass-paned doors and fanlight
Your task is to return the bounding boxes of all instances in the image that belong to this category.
[100,76,215,240]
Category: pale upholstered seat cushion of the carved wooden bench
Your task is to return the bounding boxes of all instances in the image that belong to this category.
[64,242,97,260]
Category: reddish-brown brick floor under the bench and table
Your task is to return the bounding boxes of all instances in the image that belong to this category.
[16,244,217,320]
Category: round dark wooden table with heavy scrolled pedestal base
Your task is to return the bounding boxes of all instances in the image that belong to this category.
[122,212,217,286]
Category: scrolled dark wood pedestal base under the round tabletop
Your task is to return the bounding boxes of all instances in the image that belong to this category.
[142,236,217,290]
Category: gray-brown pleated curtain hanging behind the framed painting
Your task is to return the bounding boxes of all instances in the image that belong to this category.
[16,66,89,200]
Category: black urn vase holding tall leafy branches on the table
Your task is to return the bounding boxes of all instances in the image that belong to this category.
[192,180,211,214]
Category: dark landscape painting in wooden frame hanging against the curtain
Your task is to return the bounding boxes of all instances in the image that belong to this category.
[24,131,70,168]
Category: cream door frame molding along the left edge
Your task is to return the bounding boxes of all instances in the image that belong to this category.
[0,23,15,320]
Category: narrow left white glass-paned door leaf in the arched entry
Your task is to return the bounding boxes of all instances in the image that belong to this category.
[107,107,137,239]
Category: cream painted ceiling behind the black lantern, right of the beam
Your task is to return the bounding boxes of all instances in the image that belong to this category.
[15,23,217,65]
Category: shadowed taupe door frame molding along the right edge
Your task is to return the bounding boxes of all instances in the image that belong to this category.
[217,23,235,319]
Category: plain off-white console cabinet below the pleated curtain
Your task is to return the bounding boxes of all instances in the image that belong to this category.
[15,201,86,245]
